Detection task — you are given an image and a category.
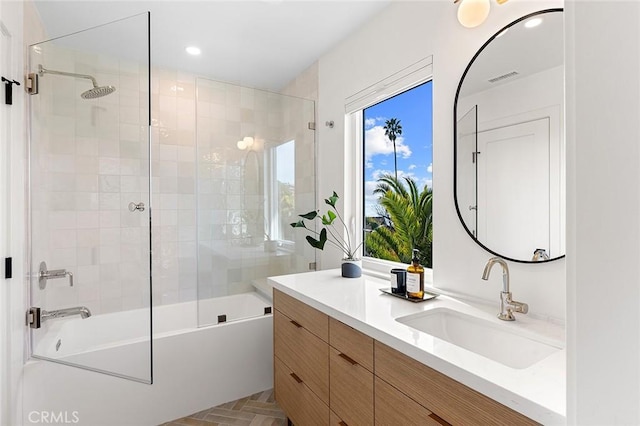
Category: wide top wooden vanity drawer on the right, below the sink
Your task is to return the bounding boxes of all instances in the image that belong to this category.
[375,342,537,426]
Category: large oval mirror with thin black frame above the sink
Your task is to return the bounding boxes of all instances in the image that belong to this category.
[454,9,565,262]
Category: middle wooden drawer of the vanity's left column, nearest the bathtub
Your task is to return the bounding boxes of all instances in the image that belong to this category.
[273,309,329,404]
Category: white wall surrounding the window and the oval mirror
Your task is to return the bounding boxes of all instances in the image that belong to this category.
[318,1,565,319]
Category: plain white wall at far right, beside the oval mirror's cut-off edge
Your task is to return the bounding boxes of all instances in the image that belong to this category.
[565,0,640,425]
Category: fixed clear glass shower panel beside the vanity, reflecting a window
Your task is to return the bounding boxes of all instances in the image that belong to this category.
[196,78,316,326]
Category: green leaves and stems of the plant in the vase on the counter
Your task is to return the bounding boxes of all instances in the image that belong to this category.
[291,191,362,259]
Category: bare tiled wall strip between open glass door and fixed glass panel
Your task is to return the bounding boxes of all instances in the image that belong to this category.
[151,68,197,304]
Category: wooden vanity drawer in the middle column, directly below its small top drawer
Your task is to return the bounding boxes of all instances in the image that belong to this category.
[329,348,373,426]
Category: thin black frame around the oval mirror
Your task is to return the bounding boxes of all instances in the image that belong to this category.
[453,7,566,264]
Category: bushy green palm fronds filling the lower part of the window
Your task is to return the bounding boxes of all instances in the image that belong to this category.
[366,175,433,268]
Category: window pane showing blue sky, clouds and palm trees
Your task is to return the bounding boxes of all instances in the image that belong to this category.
[362,81,433,268]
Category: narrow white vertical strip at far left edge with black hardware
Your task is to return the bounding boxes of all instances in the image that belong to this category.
[0,0,26,424]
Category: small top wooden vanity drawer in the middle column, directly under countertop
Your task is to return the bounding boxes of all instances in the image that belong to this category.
[329,318,373,371]
